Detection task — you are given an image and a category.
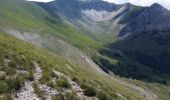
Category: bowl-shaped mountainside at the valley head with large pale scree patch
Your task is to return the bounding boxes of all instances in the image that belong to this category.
[36,0,145,44]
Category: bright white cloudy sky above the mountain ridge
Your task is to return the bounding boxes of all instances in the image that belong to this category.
[29,0,170,9]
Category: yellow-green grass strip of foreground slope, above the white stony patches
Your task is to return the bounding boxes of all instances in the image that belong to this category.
[0,32,142,100]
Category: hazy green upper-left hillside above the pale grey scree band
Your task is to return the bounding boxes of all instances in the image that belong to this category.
[0,0,100,51]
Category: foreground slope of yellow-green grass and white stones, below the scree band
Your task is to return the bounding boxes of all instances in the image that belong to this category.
[0,32,146,100]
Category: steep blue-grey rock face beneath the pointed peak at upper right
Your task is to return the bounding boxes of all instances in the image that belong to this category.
[119,4,170,37]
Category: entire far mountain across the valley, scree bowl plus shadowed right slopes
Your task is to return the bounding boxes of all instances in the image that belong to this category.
[36,0,170,82]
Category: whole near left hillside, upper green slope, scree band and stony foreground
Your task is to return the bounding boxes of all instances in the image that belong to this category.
[0,0,147,100]
